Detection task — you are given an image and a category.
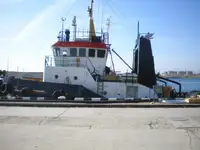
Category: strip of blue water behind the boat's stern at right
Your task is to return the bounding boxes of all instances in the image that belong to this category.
[158,78,200,92]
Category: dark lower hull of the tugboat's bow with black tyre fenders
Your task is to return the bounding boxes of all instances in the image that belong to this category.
[1,78,101,98]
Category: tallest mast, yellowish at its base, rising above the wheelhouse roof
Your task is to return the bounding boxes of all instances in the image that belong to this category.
[88,0,95,41]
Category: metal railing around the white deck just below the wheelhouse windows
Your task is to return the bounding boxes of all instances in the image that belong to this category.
[45,56,88,67]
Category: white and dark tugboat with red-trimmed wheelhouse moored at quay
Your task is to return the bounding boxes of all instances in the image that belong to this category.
[1,0,173,99]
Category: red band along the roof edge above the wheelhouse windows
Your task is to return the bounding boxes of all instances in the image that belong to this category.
[53,42,106,49]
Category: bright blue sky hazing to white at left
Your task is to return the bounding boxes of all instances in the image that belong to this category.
[0,0,200,72]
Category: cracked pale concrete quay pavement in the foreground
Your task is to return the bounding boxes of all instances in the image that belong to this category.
[0,107,200,150]
